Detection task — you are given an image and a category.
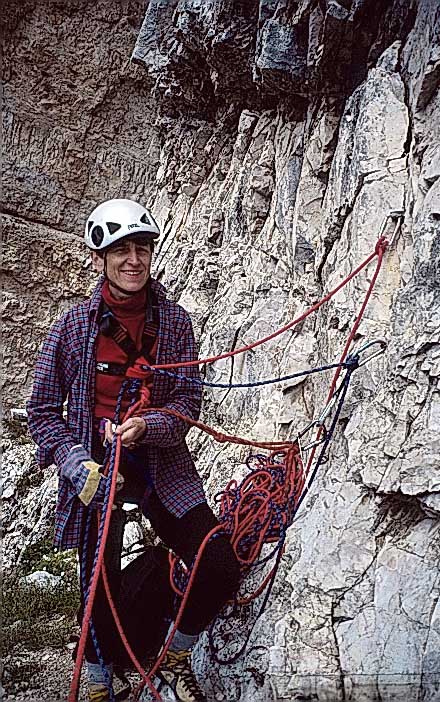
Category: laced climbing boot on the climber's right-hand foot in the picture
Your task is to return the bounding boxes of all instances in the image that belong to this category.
[159,650,206,702]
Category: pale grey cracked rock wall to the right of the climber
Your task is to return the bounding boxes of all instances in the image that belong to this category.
[135,2,440,700]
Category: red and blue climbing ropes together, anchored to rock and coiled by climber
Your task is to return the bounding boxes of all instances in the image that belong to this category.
[69,232,394,702]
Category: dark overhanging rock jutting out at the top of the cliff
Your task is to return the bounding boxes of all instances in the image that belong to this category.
[133,0,417,117]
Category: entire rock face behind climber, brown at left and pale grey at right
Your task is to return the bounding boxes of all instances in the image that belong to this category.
[1,0,440,702]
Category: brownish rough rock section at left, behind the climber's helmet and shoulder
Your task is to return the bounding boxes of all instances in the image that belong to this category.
[1,0,159,407]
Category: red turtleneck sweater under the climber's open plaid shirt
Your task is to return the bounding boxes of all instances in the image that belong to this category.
[95,280,157,420]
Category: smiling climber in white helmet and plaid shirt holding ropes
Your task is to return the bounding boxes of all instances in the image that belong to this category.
[28,199,239,702]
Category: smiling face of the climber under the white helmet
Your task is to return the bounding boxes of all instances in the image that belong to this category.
[92,237,152,300]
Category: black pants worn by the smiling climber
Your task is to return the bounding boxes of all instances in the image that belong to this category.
[80,492,240,663]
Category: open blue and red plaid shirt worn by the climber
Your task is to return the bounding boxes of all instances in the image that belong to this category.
[27,279,206,549]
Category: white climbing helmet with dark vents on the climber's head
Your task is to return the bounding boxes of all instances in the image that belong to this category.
[84,199,160,251]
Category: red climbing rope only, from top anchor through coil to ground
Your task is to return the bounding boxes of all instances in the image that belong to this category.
[69,237,388,702]
